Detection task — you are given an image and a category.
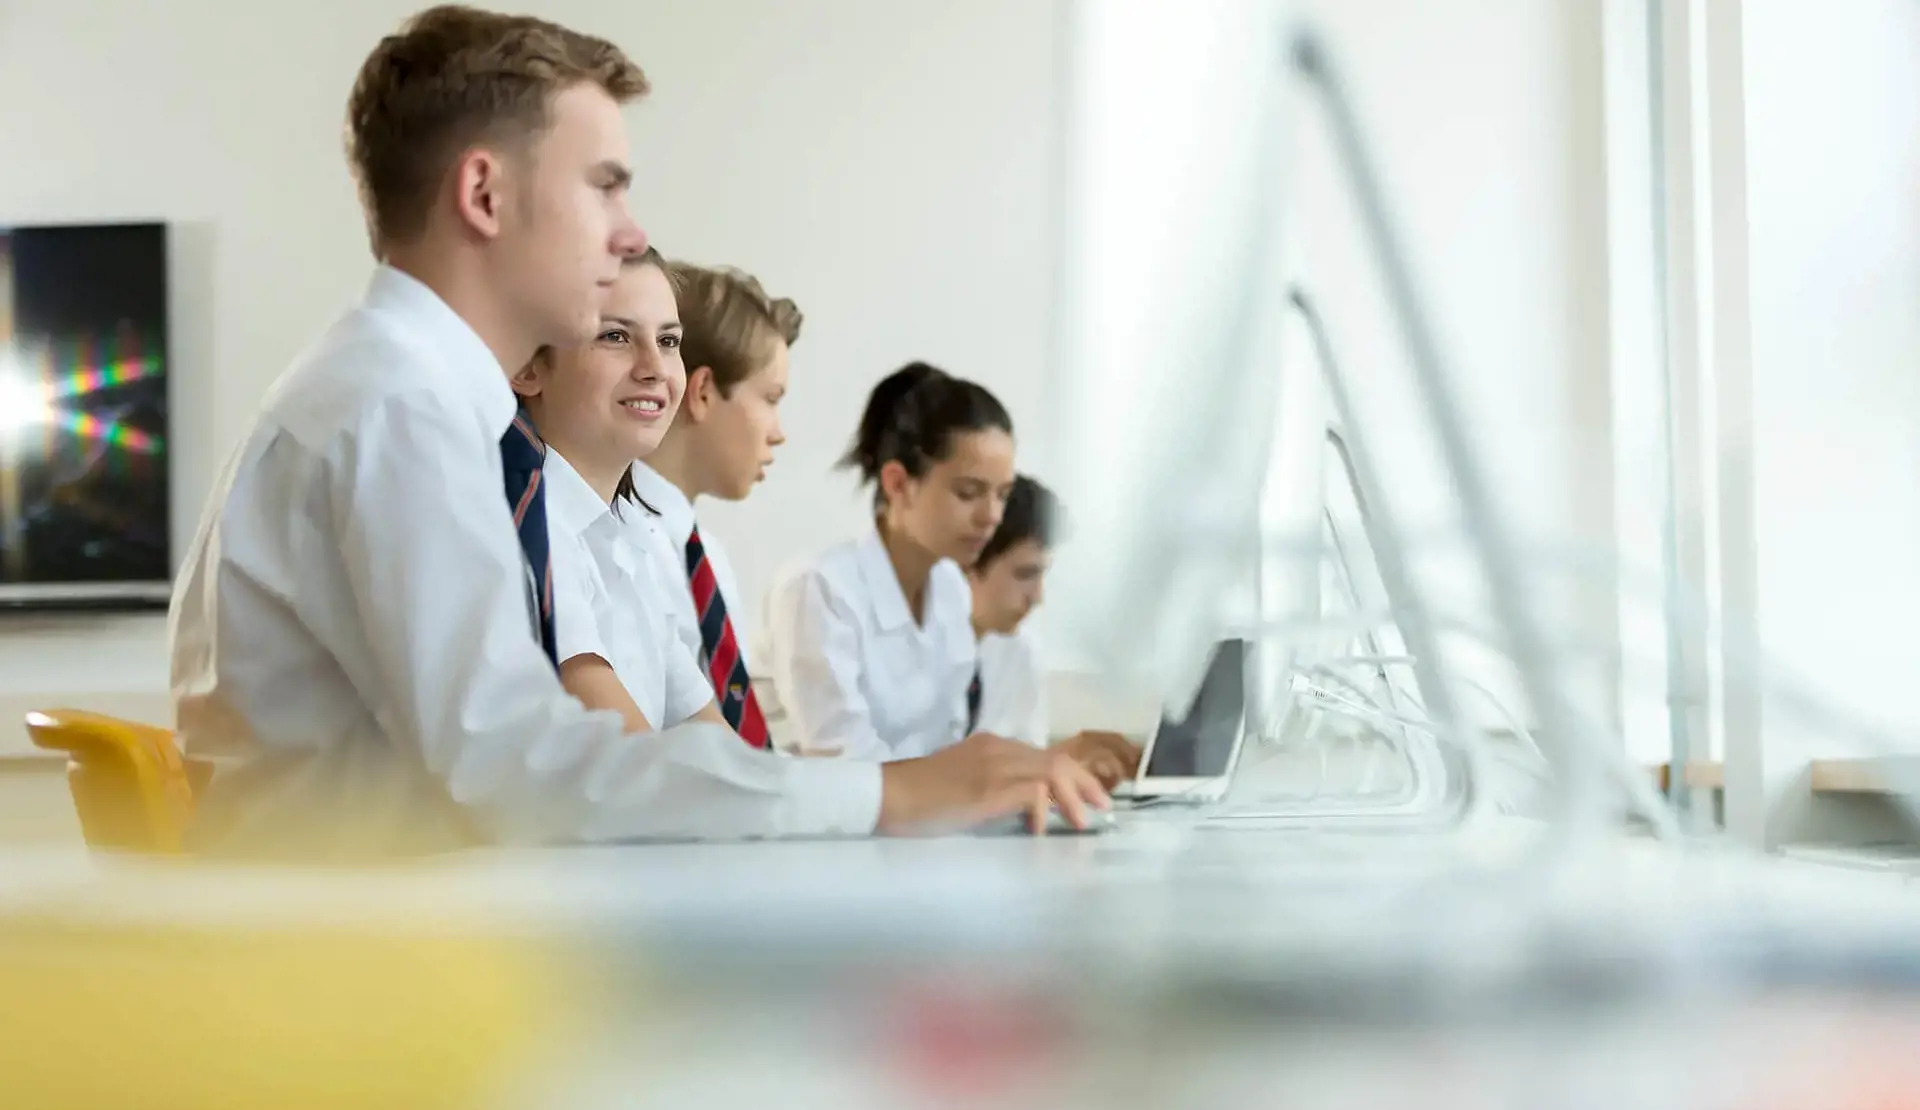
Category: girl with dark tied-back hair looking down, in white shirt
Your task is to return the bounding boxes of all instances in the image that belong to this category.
[766,363,1014,760]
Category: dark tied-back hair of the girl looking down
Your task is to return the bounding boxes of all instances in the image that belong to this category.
[839,363,1014,505]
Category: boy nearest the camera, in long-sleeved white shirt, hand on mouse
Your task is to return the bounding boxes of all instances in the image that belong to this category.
[169,6,1104,858]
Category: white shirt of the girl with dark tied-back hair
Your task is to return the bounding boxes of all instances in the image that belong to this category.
[766,530,973,760]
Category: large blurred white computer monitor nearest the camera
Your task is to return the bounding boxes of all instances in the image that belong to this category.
[1048,0,1323,705]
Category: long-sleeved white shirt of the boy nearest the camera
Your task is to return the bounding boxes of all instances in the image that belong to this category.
[167,267,879,855]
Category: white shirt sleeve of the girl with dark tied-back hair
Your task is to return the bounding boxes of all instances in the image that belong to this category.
[766,560,895,762]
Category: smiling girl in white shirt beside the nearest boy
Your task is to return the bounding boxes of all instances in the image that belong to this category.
[513,248,726,732]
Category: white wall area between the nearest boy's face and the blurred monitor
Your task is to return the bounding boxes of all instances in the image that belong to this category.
[614,0,1062,595]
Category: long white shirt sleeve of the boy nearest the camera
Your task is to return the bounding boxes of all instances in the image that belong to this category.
[328,396,879,841]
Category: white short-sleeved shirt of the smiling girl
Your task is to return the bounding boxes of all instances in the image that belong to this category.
[541,447,714,728]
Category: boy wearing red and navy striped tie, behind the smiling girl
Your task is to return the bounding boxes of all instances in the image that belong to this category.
[634,261,801,745]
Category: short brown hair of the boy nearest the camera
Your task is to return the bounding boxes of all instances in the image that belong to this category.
[348,4,647,257]
